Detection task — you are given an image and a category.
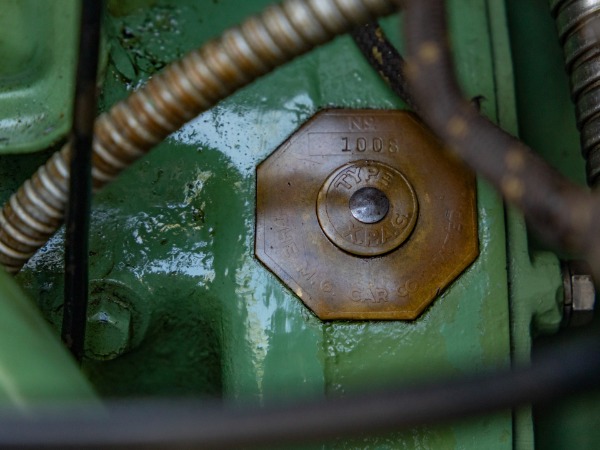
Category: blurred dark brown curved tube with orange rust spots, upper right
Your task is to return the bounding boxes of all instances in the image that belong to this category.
[405,0,600,282]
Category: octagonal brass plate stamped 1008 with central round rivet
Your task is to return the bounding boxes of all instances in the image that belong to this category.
[255,110,479,320]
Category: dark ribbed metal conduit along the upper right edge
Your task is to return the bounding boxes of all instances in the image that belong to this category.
[550,0,600,186]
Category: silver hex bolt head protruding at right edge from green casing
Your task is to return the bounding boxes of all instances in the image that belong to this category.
[562,261,596,327]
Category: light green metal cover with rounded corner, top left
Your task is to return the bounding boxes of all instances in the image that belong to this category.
[0,0,79,154]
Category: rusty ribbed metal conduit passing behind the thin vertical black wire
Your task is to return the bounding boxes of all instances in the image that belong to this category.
[0,0,395,273]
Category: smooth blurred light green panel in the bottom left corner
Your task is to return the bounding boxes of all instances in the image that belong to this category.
[0,271,97,412]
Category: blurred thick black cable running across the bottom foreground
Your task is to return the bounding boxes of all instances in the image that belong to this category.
[0,335,600,449]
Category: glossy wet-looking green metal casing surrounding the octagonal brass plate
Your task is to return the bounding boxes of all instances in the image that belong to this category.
[0,0,583,449]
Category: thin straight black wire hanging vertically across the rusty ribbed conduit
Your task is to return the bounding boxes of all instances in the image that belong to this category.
[62,0,102,361]
